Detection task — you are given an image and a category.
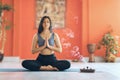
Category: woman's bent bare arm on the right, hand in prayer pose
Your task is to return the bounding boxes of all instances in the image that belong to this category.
[47,33,62,53]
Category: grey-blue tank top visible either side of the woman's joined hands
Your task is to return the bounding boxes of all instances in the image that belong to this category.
[38,33,54,46]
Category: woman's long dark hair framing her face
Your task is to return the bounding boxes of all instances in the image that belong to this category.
[38,16,52,34]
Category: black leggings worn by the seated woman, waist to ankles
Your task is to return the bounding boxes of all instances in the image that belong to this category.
[22,54,70,71]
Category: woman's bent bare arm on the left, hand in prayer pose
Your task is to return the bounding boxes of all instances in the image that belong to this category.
[32,34,46,54]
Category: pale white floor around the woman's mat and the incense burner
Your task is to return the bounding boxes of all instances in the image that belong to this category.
[0,59,120,80]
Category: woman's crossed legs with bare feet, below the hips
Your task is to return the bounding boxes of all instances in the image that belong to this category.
[22,60,70,71]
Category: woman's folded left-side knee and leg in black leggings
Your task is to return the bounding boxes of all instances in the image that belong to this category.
[22,60,41,71]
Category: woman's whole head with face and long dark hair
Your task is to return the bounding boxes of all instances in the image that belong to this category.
[38,16,52,33]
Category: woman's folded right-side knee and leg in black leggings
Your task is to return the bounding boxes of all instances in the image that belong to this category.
[52,60,71,71]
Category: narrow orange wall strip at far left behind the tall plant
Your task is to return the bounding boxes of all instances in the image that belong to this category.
[1,0,13,56]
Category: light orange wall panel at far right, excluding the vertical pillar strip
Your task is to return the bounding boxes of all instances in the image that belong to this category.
[89,0,120,56]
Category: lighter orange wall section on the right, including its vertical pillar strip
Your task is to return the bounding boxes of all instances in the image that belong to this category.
[82,0,120,56]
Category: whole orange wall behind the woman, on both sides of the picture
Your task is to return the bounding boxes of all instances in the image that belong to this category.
[2,0,120,59]
